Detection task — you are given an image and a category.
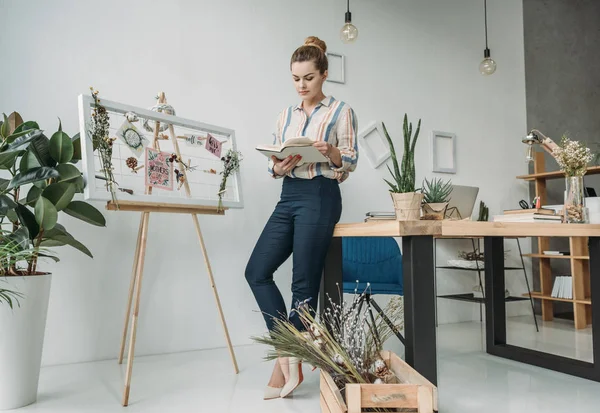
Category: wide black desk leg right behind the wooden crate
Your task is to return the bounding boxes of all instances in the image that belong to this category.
[402,235,437,386]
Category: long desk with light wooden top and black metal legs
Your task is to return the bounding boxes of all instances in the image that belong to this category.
[319,221,600,385]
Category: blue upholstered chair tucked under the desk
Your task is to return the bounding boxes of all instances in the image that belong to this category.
[342,237,404,344]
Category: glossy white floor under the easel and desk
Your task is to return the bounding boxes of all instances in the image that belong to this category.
[9,317,600,413]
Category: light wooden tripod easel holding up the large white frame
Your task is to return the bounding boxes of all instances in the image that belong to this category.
[111,93,239,406]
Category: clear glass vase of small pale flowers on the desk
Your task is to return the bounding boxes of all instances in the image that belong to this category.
[552,135,593,224]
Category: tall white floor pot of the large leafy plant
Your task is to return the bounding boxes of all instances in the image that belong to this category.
[0,274,52,410]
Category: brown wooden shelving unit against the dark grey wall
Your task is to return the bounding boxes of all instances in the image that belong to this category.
[517,152,600,329]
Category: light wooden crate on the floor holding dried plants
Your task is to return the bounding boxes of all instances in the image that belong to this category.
[320,351,438,413]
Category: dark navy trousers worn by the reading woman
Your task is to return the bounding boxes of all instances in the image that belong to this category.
[246,177,342,331]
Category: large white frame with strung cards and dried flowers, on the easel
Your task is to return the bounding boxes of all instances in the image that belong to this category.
[78,94,244,208]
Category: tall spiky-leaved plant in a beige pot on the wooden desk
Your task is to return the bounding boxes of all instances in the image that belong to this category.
[382,114,423,221]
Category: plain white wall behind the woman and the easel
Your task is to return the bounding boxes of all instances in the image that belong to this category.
[0,0,527,365]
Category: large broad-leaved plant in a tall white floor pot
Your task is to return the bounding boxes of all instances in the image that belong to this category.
[0,113,106,410]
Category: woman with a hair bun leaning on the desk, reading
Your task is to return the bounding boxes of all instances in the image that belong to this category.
[246,36,358,399]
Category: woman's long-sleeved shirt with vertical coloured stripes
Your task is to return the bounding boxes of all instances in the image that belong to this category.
[268,96,358,182]
